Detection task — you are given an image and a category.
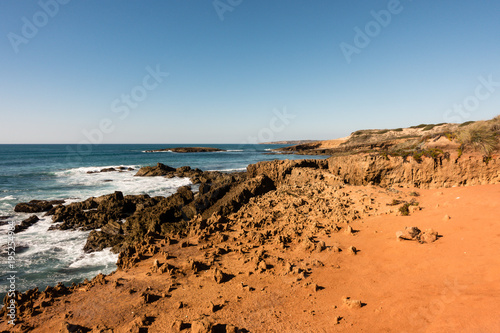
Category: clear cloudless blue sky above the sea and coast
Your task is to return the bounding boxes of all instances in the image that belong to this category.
[0,0,500,143]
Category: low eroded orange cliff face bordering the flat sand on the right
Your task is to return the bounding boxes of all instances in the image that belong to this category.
[248,155,500,188]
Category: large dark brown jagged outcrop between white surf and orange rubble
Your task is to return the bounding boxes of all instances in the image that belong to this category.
[49,166,266,252]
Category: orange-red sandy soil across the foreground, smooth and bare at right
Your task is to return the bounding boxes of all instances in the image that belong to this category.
[0,184,500,333]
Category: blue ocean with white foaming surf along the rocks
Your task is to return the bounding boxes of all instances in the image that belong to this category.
[0,144,320,297]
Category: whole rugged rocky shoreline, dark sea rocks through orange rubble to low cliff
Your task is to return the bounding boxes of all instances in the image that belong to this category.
[0,152,500,332]
